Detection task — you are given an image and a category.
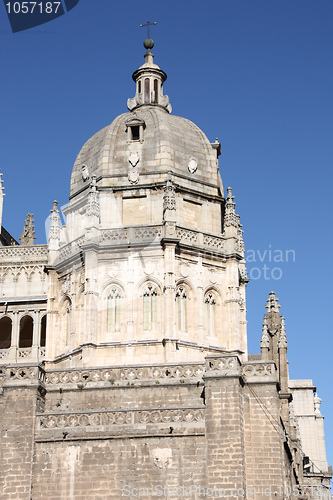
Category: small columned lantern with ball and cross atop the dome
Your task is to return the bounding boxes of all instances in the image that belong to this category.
[127,36,172,113]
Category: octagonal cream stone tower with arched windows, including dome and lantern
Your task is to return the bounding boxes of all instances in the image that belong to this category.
[46,39,247,366]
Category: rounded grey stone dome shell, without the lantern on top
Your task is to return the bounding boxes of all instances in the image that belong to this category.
[71,104,219,196]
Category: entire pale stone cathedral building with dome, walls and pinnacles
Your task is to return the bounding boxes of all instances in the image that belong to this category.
[0,41,331,500]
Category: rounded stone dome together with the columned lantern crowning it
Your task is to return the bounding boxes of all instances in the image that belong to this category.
[71,40,223,197]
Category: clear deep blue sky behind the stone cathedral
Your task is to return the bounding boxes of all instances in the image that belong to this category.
[0,0,333,464]
